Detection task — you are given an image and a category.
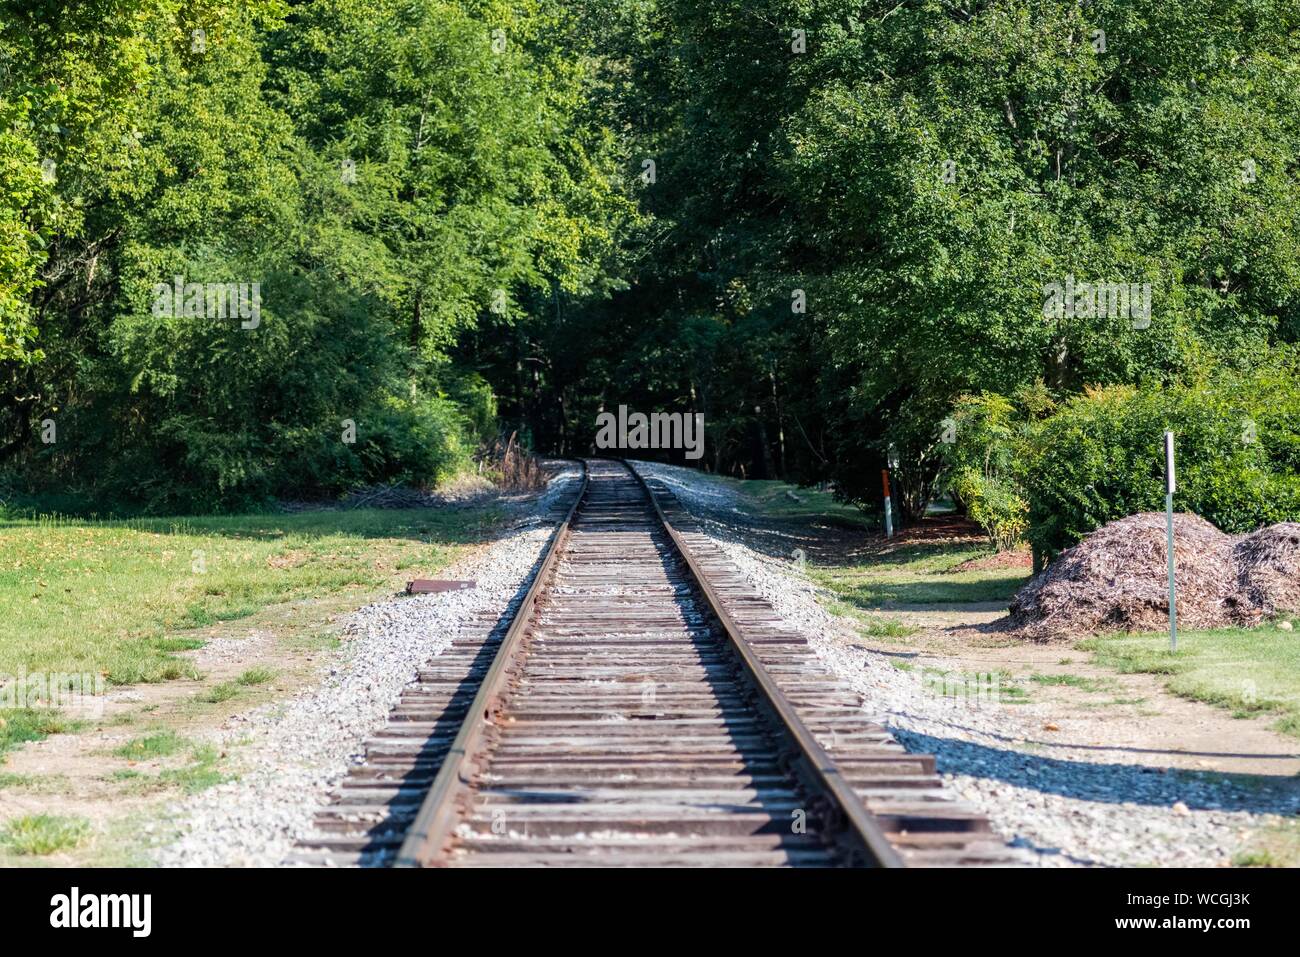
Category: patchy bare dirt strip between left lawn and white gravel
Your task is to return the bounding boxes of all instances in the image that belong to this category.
[0,564,485,866]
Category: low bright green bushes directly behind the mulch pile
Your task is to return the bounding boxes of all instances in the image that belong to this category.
[945,364,1300,559]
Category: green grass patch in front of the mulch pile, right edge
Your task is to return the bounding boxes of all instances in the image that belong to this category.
[1079,625,1300,737]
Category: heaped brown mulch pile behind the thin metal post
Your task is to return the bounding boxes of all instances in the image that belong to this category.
[998,512,1300,641]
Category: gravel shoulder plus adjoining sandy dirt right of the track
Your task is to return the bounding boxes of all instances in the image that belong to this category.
[636,463,1300,866]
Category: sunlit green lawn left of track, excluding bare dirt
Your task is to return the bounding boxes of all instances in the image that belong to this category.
[0,508,498,684]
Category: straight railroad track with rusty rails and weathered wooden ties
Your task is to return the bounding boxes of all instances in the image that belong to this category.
[289,460,1023,867]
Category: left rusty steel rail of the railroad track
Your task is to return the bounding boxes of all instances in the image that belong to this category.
[393,462,590,867]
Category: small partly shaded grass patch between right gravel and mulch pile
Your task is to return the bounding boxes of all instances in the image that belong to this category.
[809,542,1028,609]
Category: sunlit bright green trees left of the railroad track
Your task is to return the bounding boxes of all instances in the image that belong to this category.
[0,0,632,511]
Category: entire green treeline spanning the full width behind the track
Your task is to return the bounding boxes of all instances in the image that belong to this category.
[0,0,1300,557]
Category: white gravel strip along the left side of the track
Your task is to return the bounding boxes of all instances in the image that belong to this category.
[152,467,579,867]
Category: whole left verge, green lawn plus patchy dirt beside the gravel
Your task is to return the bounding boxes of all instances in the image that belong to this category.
[0,494,517,866]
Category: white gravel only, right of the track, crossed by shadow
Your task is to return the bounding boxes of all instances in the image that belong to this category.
[637,463,1300,866]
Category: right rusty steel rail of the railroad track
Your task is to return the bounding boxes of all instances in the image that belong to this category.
[619,459,905,867]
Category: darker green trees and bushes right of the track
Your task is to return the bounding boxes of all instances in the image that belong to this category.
[488,0,1300,555]
